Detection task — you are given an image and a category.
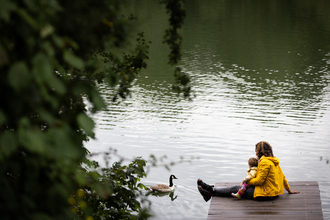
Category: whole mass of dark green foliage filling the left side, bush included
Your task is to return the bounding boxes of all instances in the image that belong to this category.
[0,0,188,220]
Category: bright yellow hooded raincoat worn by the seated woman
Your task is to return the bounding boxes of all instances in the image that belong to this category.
[248,156,290,197]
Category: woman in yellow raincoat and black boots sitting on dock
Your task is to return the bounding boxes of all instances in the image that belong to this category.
[197,141,299,202]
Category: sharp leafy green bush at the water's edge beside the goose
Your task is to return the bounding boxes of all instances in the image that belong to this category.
[84,155,150,220]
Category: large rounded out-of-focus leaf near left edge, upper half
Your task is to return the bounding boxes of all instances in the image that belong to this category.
[8,61,30,91]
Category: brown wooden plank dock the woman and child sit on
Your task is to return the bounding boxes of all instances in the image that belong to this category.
[207,181,323,220]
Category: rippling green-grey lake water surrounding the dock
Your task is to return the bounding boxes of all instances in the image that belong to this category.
[86,0,330,220]
